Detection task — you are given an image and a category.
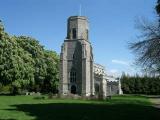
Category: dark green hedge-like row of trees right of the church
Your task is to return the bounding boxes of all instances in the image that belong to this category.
[121,74,160,95]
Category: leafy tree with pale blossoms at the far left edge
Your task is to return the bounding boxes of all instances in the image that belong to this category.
[0,33,34,93]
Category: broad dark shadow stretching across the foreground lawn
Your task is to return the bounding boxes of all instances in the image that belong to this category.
[6,103,160,120]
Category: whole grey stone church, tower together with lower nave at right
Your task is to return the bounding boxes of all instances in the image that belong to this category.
[59,16,121,98]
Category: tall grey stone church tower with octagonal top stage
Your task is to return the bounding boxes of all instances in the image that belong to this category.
[59,16,95,96]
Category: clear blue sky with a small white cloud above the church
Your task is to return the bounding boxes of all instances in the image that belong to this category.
[0,0,156,74]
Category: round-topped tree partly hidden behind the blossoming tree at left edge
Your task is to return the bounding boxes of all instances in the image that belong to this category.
[14,36,47,91]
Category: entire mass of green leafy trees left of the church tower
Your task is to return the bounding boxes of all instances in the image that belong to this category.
[0,20,59,92]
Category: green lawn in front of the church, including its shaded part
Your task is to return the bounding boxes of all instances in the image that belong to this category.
[0,96,160,120]
